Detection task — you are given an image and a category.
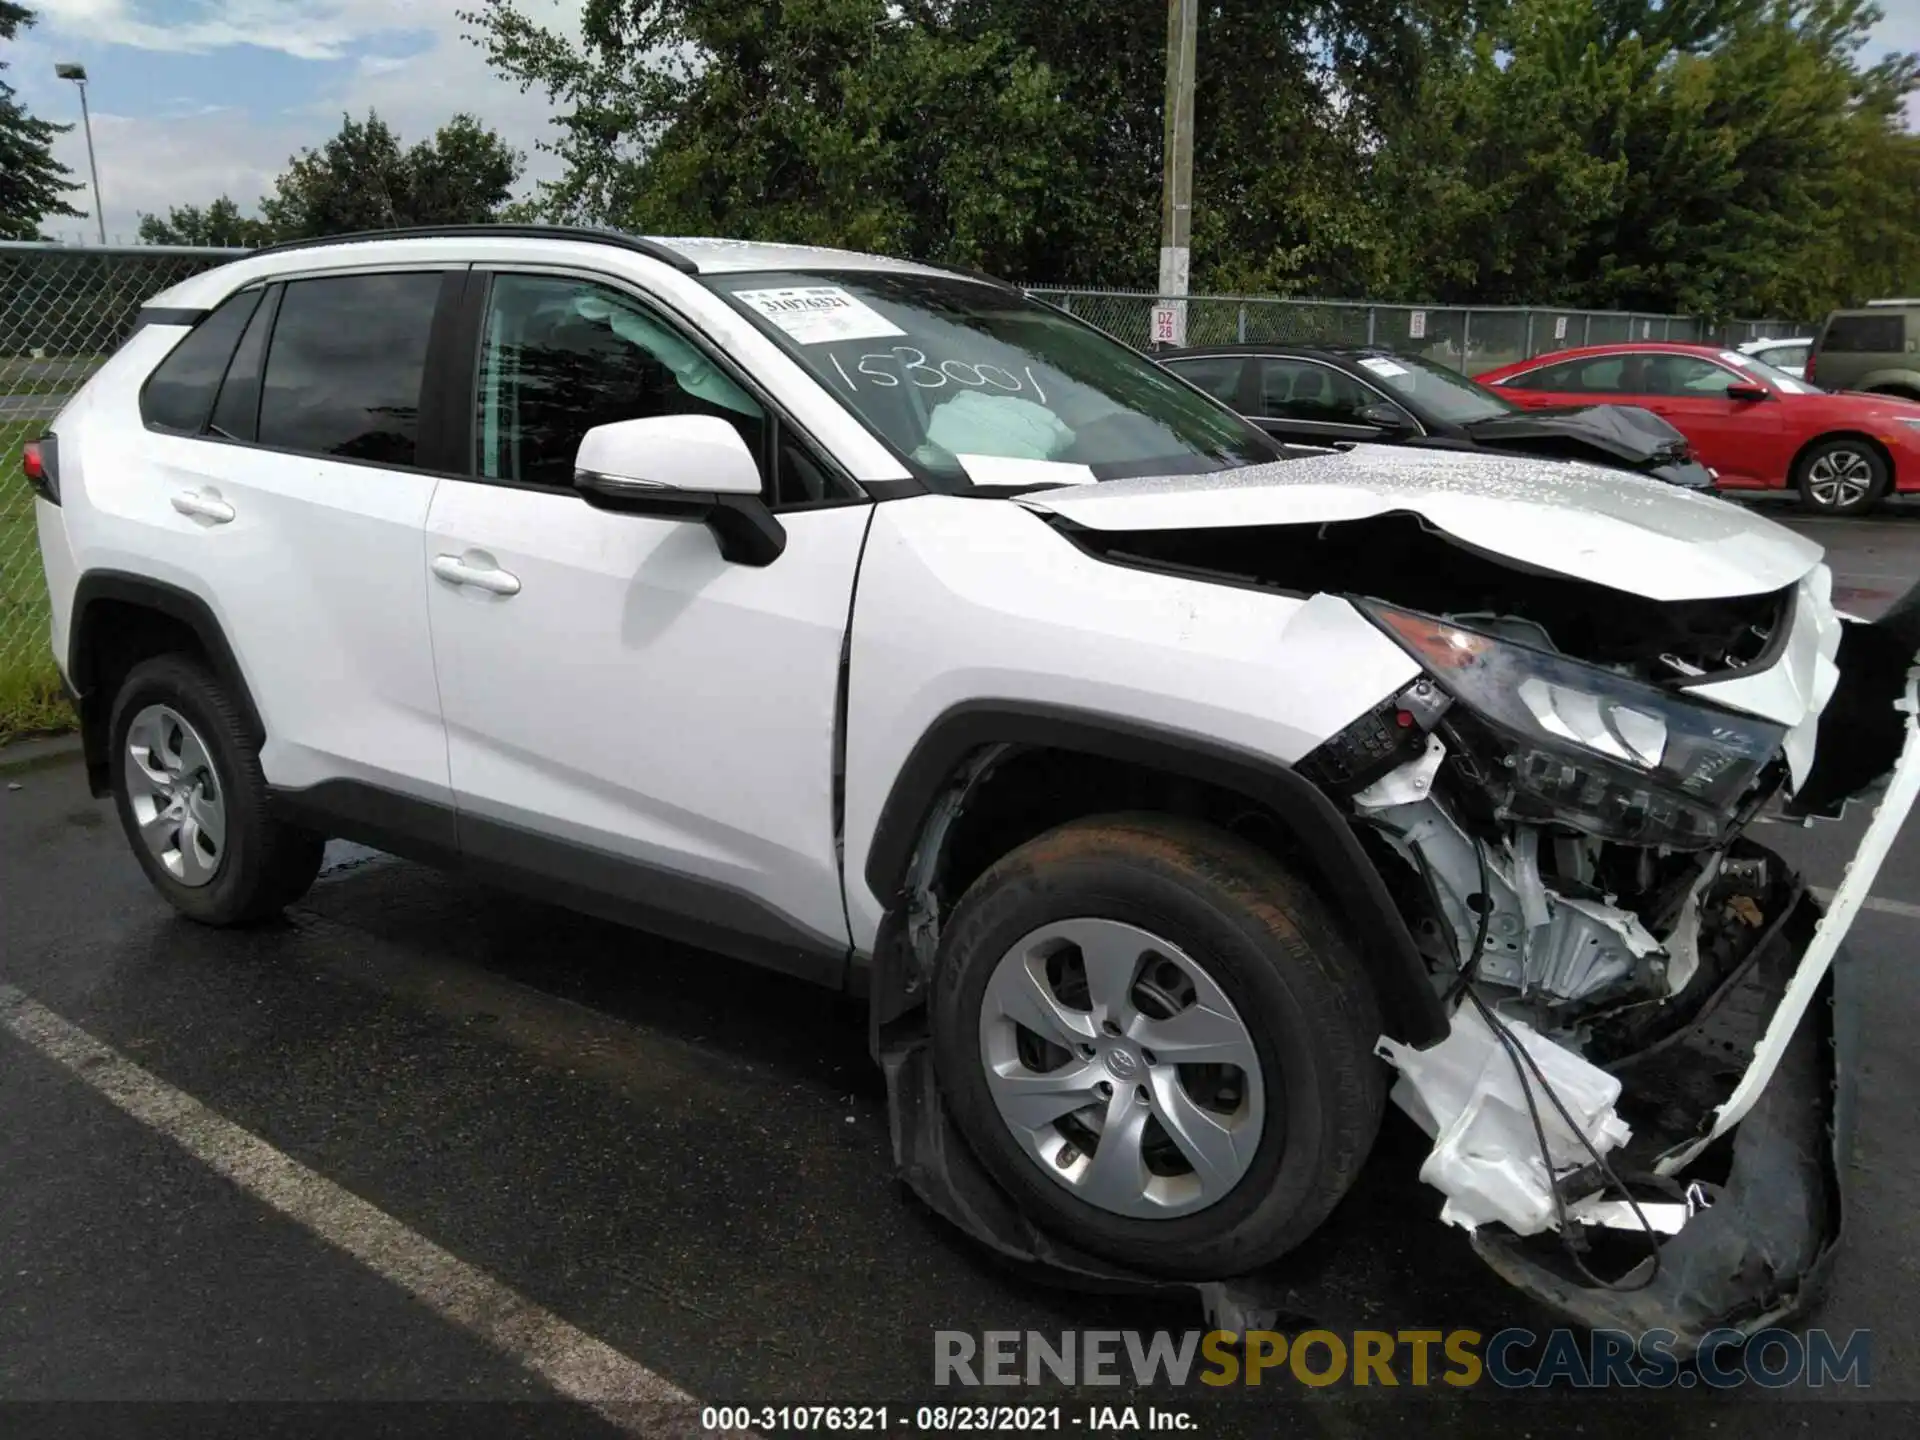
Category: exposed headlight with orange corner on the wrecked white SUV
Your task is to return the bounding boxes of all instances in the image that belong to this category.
[1357,601,1786,849]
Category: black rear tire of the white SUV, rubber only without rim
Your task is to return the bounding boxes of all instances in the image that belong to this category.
[108,655,326,925]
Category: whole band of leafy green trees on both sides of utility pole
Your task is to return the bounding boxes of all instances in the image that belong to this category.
[467,0,1920,315]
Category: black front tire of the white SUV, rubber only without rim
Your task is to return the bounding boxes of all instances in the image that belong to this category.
[933,814,1386,1279]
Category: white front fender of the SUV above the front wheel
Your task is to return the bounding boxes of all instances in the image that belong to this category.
[843,495,1417,950]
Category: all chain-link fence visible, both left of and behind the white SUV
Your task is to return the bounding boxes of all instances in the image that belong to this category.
[0,242,1795,737]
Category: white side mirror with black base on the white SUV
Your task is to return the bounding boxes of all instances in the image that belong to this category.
[574,415,787,564]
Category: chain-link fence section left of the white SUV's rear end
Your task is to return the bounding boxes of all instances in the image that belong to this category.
[0,242,240,737]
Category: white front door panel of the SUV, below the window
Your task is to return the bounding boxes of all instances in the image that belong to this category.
[417,480,874,954]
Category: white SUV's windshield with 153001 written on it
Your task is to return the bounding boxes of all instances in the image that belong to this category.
[708,271,1286,492]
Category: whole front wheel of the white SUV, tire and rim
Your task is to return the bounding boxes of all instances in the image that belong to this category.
[933,816,1384,1279]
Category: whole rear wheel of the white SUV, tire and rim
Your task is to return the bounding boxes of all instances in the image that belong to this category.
[109,655,326,925]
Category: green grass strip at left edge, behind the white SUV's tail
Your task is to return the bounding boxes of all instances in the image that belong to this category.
[0,420,73,739]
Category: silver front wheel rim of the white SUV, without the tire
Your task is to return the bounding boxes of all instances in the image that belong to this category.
[979,918,1265,1219]
